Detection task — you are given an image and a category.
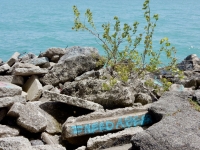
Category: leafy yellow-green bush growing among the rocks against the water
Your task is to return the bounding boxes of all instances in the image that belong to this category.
[72,0,181,91]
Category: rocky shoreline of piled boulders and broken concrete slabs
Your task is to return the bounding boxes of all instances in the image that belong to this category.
[0,46,200,150]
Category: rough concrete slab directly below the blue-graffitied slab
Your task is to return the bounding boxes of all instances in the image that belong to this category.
[87,127,143,150]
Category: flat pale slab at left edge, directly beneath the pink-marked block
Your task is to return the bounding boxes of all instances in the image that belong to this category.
[0,95,26,108]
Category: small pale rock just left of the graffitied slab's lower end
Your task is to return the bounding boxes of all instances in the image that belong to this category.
[41,132,60,144]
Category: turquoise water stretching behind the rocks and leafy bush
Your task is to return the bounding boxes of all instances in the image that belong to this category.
[0,0,200,61]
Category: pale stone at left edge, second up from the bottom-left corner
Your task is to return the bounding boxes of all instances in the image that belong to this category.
[0,125,19,138]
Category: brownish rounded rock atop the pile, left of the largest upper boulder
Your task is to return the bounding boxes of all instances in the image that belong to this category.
[38,47,65,63]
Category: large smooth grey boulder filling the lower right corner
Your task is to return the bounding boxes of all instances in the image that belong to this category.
[132,91,200,150]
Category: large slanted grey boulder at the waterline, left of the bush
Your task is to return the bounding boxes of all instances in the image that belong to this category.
[40,47,102,85]
